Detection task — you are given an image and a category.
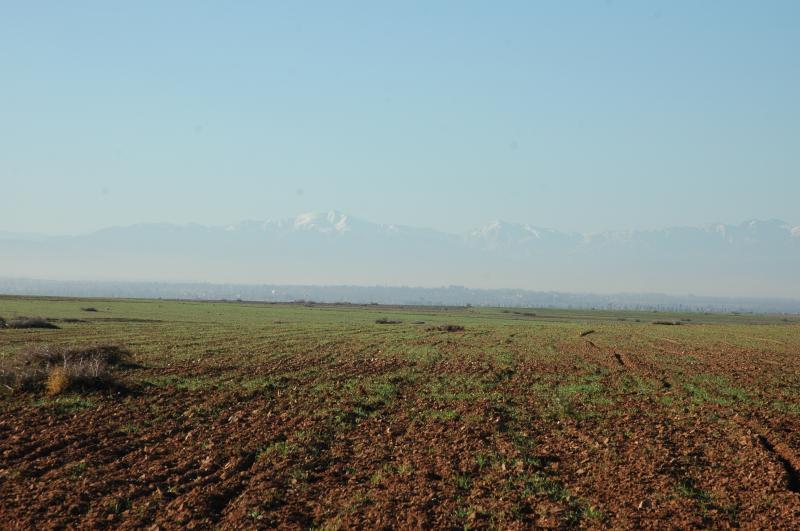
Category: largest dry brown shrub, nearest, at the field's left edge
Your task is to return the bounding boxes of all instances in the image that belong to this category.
[0,345,129,394]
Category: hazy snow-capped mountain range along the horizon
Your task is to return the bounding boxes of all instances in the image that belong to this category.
[0,211,800,304]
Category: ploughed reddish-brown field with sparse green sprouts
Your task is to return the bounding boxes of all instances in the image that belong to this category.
[0,298,800,529]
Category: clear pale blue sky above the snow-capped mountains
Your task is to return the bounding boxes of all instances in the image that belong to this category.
[0,1,800,233]
